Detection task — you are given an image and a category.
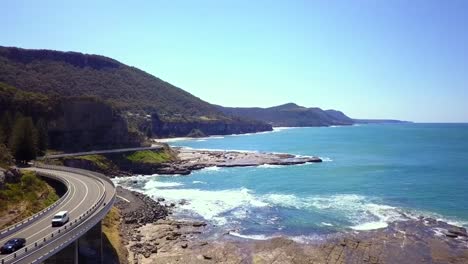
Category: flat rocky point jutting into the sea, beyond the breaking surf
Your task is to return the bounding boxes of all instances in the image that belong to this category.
[57,145,322,177]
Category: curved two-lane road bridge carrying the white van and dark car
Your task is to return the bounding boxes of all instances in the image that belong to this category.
[0,165,116,264]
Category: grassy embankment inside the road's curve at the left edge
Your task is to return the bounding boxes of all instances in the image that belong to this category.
[0,171,59,228]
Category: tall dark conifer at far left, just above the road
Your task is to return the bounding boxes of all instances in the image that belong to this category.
[10,117,37,163]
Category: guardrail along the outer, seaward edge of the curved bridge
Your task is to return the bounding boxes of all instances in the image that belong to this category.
[0,165,116,264]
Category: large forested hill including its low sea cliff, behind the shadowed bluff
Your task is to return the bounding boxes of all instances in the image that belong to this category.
[0,47,271,136]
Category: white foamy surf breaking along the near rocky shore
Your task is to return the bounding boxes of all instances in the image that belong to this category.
[126,173,466,230]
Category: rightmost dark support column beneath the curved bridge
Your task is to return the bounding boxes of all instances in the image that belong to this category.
[78,221,103,264]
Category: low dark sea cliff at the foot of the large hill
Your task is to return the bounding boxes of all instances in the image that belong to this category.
[152,114,272,137]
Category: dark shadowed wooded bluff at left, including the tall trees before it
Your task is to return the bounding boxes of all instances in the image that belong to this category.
[0,82,142,157]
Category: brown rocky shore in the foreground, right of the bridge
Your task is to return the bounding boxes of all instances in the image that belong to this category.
[116,187,468,264]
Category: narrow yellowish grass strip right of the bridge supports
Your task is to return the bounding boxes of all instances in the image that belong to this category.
[102,207,127,263]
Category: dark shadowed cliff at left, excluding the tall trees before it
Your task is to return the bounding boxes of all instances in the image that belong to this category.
[0,83,142,153]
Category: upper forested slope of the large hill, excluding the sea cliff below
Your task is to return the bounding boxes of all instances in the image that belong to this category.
[0,47,224,119]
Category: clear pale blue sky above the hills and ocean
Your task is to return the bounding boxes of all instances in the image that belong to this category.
[0,0,468,122]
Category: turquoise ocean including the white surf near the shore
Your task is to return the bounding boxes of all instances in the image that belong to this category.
[115,124,468,242]
